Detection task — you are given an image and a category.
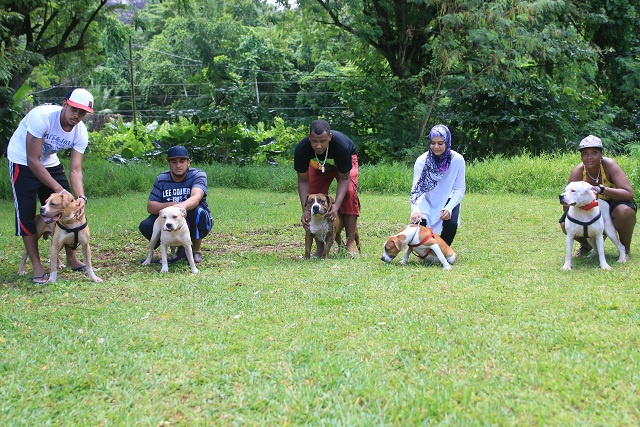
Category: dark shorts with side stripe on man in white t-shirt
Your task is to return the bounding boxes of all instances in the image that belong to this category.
[9,162,70,236]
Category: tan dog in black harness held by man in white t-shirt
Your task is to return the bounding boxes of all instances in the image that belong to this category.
[40,190,102,283]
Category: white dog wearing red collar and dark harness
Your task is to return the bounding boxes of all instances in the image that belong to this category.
[560,181,627,270]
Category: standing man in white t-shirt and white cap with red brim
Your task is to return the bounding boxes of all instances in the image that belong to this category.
[7,88,93,284]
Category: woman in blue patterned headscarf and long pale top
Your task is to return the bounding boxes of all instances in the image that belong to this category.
[410,125,466,246]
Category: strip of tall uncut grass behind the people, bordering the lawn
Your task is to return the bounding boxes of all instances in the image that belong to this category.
[0,151,640,202]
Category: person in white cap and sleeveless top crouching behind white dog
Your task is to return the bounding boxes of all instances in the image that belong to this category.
[560,135,637,258]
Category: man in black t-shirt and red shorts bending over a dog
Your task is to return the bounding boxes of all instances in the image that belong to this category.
[293,120,360,256]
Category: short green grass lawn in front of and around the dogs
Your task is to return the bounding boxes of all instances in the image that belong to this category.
[0,188,640,426]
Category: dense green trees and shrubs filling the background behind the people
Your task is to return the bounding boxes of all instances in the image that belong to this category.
[0,0,640,163]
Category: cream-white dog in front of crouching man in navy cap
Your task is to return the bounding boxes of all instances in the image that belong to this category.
[142,206,198,274]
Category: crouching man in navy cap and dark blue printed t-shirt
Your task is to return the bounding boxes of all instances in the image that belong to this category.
[138,145,213,263]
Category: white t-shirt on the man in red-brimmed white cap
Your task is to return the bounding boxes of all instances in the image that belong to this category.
[7,105,89,168]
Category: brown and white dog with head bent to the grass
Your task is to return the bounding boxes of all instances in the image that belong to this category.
[380,224,458,270]
